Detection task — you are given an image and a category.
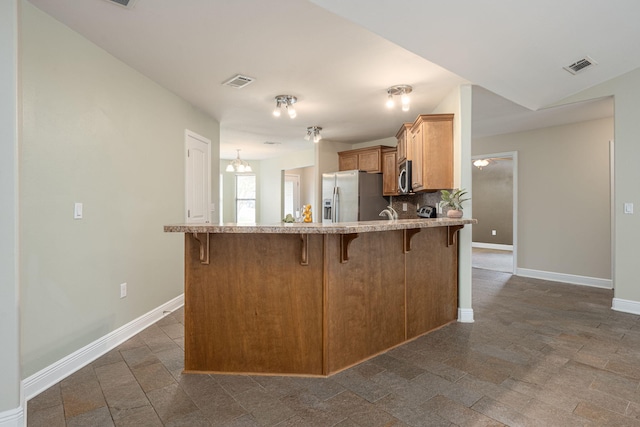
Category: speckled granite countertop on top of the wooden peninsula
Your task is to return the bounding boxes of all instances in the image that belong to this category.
[164,218,478,234]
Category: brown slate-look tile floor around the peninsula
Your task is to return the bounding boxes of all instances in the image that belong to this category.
[28,269,640,427]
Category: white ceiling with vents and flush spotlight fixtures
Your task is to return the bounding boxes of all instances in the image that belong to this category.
[29,0,640,160]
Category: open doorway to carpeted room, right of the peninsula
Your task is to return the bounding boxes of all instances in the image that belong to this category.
[471,151,518,274]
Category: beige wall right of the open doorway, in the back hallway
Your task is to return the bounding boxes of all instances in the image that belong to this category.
[473,118,613,279]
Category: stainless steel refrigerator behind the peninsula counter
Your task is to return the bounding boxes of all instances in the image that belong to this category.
[322,170,389,224]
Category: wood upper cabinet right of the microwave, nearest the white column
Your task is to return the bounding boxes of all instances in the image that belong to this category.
[410,114,453,191]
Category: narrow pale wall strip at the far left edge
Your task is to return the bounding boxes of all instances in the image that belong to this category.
[0,0,22,414]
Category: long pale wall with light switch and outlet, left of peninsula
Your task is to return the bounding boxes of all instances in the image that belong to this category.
[20,2,219,377]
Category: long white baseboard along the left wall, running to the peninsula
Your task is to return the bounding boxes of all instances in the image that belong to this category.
[22,294,184,402]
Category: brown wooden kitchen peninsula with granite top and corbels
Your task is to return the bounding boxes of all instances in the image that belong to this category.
[164,218,476,376]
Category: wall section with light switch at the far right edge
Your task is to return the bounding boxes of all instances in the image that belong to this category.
[561,69,640,304]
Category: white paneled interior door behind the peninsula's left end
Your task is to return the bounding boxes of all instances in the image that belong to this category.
[185,130,211,223]
